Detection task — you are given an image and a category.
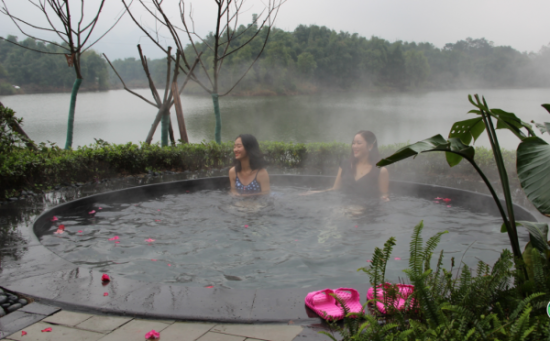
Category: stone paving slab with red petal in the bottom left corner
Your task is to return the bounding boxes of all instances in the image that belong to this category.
[9,322,104,341]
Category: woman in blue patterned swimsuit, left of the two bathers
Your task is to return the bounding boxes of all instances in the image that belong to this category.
[229,134,270,196]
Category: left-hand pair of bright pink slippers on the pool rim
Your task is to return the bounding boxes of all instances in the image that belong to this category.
[305,288,363,320]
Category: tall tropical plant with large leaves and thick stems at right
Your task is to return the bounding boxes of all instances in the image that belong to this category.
[377,95,550,274]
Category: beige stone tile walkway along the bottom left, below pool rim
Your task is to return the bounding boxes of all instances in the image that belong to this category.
[0,303,328,341]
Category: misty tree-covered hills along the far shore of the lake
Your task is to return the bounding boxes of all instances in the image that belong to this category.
[0,25,550,95]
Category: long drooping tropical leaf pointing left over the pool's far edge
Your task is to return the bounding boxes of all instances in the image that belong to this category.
[376,135,475,167]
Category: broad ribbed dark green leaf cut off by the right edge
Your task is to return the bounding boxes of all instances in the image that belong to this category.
[516,137,550,217]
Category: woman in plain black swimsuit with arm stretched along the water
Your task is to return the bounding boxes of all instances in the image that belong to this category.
[306,130,389,201]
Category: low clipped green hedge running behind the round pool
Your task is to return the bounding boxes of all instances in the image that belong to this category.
[0,142,515,197]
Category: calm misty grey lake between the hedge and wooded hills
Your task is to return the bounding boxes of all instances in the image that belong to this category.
[0,89,550,149]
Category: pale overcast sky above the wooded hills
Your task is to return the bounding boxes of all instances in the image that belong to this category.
[0,0,550,59]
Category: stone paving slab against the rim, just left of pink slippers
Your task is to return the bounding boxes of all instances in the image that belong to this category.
[212,324,303,341]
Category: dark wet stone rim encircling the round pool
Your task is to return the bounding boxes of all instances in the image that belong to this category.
[0,175,537,323]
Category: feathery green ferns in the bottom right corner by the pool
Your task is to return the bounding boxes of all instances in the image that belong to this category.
[324,222,550,341]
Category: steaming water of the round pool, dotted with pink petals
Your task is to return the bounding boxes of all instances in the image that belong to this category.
[34,175,534,288]
